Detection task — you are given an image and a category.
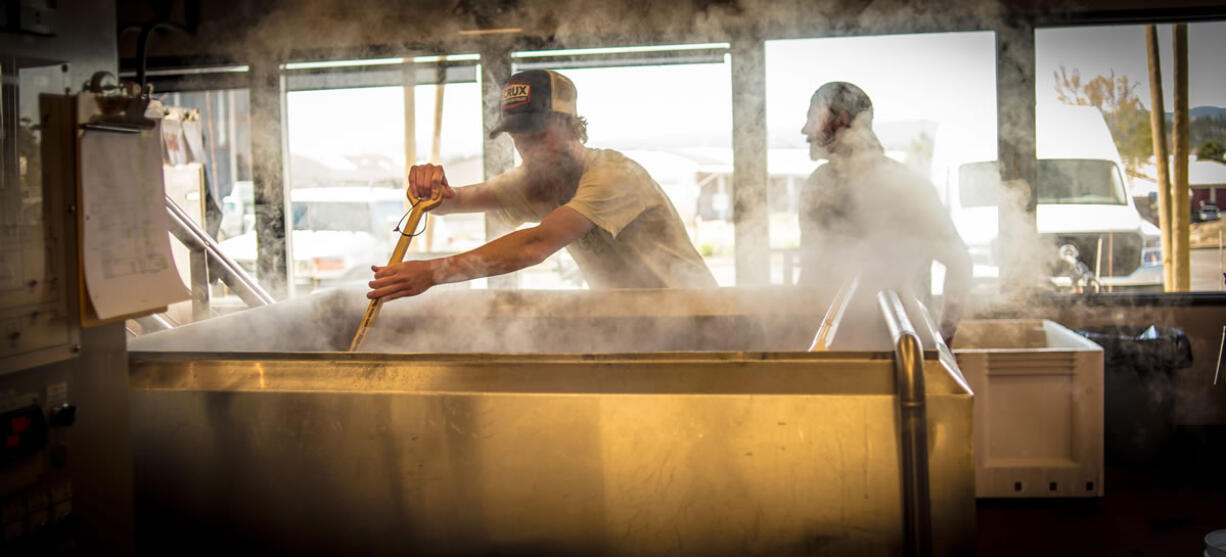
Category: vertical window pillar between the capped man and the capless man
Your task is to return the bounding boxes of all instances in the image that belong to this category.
[732,37,769,286]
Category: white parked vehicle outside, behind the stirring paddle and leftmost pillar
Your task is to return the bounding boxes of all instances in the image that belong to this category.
[221,186,447,285]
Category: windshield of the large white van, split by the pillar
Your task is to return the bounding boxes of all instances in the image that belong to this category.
[958,158,1128,207]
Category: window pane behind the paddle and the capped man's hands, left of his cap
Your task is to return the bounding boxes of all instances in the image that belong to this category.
[286,55,485,294]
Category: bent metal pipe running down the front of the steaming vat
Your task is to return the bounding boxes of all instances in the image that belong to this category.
[877,290,932,556]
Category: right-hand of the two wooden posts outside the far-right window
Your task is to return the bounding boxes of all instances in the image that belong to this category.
[1171,23,1192,292]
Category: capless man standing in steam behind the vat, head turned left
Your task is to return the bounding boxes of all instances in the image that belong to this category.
[799,81,971,344]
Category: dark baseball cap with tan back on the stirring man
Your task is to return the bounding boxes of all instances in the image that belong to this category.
[489,70,579,137]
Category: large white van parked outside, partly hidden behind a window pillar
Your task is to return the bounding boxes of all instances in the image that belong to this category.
[932,104,1162,292]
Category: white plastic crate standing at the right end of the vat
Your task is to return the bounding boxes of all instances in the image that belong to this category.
[954,319,1103,498]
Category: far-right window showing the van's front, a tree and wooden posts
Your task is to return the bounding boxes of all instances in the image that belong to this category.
[1035,22,1226,291]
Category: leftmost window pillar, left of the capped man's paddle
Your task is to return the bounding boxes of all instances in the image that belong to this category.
[250,60,292,299]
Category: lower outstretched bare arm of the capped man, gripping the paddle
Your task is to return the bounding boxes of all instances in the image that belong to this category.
[367,206,595,302]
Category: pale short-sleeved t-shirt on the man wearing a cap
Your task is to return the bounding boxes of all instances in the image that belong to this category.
[487,148,716,288]
